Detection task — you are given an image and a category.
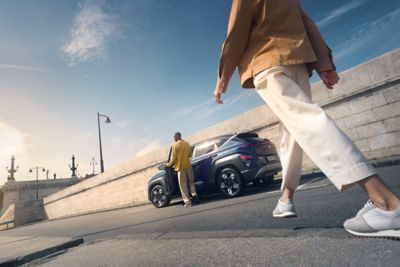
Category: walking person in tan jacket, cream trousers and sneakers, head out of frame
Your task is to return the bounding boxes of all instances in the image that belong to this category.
[214,0,400,237]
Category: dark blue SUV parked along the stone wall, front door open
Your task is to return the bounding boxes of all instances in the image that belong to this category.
[148,133,282,208]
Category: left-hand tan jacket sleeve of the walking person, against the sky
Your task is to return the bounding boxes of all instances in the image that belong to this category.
[216,0,253,93]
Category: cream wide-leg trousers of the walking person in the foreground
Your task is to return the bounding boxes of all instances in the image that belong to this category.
[254,65,376,190]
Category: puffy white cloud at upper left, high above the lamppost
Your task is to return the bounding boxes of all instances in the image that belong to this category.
[62,0,119,66]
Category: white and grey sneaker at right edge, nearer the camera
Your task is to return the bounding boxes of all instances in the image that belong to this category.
[343,201,400,239]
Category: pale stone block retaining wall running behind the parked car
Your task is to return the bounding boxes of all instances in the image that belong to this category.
[44,49,400,219]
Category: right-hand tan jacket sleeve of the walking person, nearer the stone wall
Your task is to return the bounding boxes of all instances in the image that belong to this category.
[300,8,336,73]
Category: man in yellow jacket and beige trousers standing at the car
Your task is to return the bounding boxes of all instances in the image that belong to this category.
[167,132,198,208]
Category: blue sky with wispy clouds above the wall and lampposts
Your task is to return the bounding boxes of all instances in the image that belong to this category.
[0,0,400,184]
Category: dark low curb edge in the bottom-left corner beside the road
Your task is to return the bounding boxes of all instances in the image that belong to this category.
[0,238,84,267]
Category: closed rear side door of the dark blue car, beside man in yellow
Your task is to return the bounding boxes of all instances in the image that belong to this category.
[192,141,217,186]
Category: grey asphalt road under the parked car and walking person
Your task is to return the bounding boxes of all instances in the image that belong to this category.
[1,166,400,266]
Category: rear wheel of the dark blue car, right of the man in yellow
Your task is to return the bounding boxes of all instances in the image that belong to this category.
[217,168,246,198]
